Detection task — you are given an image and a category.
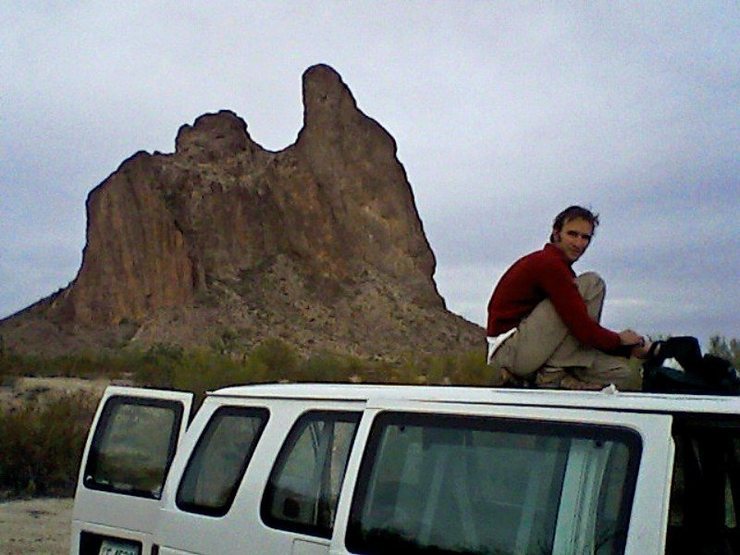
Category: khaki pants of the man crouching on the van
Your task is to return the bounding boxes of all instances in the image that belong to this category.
[490,272,641,390]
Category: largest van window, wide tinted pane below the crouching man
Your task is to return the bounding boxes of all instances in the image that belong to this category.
[346,412,641,555]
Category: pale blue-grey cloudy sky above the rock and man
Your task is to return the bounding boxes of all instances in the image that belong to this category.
[0,0,740,348]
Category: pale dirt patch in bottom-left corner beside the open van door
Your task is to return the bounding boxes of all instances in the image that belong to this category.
[0,498,72,555]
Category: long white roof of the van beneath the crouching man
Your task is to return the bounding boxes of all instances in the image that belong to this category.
[208,383,740,414]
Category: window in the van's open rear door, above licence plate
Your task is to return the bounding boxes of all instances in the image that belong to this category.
[83,396,183,499]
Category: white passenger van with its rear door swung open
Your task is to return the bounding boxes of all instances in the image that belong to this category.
[70,384,740,555]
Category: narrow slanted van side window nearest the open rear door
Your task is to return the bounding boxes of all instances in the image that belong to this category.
[175,407,269,516]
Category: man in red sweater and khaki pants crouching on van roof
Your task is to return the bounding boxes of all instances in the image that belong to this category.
[487,206,649,390]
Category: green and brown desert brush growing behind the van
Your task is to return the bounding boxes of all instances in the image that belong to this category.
[0,336,740,498]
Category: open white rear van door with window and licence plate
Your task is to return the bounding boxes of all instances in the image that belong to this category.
[70,386,193,555]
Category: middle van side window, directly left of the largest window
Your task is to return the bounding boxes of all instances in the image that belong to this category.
[262,411,360,538]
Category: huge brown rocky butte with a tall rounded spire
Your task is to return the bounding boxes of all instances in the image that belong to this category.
[0,65,483,356]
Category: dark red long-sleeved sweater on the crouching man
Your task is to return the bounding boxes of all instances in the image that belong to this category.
[487,243,621,352]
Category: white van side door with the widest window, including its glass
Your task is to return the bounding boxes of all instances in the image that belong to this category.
[331,401,673,555]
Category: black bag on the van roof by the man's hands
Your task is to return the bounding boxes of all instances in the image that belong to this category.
[642,336,740,395]
